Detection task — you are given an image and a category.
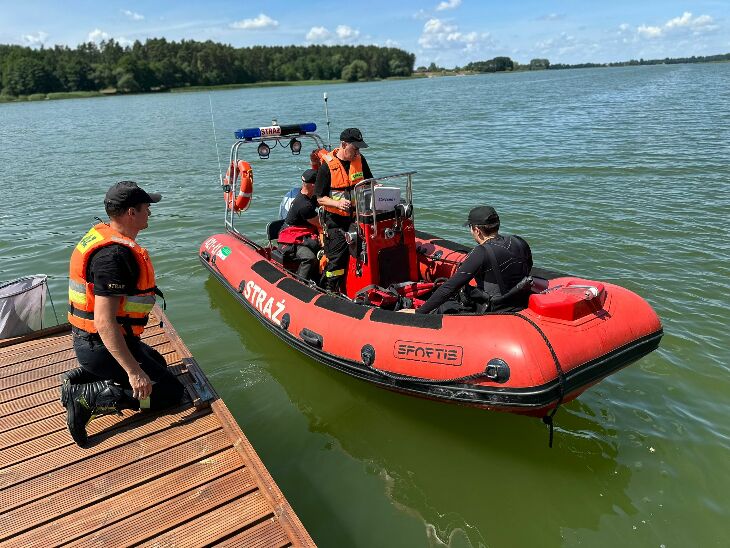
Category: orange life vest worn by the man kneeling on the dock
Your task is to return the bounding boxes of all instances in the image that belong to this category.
[68,223,162,337]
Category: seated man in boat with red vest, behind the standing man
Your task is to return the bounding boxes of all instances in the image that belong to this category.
[277,169,320,280]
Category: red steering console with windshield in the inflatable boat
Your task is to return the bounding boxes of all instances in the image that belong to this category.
[345,172,418,298]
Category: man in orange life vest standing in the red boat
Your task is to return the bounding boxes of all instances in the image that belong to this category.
[314,127,373,291]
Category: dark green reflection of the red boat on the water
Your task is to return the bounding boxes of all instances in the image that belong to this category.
[205,277,636,546]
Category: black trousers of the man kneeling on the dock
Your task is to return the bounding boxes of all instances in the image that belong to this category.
[74,334,185,409]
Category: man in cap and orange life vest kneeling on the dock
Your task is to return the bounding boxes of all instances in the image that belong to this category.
[61,181,184,446]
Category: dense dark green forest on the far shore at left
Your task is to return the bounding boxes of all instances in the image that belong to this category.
[0,38,415,96]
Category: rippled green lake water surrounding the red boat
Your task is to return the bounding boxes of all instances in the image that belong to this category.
[0,63,730,547]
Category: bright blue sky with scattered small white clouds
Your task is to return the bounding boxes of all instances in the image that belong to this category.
[0,0,730,67]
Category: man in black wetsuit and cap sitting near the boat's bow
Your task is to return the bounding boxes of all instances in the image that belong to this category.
[401,206,532,314]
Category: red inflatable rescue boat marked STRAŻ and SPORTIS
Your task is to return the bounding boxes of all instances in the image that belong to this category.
[199,124,662,424]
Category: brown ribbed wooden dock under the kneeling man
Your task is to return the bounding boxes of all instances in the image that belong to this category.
[0,308,314,548]
